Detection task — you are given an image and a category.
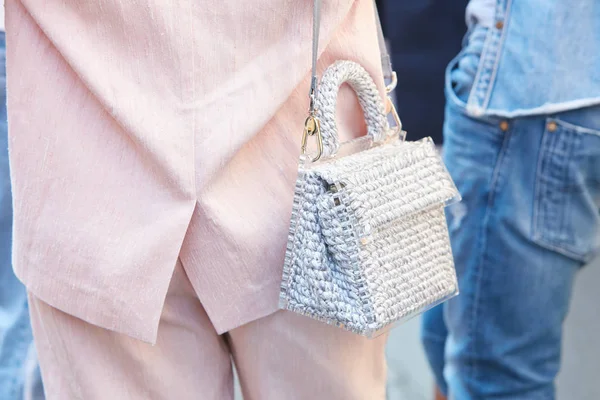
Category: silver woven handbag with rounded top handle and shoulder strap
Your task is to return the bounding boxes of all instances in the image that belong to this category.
[280,1,459,337]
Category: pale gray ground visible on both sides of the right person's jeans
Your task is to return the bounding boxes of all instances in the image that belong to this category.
[236,259,600,400]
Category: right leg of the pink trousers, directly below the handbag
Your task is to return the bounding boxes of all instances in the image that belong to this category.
[228,311,387,400]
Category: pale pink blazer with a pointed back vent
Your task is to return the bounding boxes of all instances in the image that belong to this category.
[6,0,381,342]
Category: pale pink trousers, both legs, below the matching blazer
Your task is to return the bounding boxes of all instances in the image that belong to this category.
[30,265,386,400]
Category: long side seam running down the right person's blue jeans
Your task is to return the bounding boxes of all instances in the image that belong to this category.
[469,122,512,390]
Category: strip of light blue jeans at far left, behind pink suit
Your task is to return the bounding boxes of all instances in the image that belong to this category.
[0,32,43,400]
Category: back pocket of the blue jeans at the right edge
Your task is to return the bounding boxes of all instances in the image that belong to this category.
[533,118,600,262]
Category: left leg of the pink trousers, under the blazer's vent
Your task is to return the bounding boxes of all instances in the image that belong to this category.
[30,263,233,400]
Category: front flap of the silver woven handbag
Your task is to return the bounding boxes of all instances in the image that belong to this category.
[311,139,460,228]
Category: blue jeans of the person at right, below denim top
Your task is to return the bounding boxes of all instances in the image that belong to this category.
[422,26,600,400]
